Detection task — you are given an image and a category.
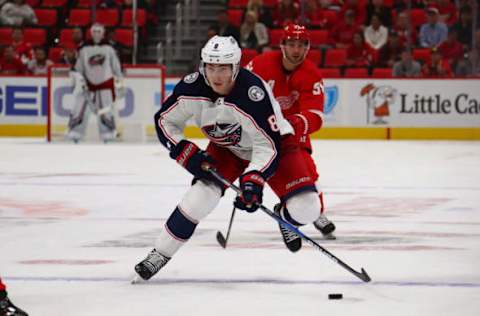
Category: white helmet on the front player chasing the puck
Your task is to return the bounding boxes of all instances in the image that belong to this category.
[199,35,242,84]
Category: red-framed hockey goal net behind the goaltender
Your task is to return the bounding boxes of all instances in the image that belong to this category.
[47,65,165,142]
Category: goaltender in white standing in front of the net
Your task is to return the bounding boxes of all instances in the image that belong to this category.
[67,23,123,142]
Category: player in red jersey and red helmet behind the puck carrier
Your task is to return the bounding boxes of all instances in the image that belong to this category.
[246,24,335,251]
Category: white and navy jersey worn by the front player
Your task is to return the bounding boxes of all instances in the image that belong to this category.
[155,69,293,178]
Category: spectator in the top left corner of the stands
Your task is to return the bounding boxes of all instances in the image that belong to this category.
[0,0,38,26]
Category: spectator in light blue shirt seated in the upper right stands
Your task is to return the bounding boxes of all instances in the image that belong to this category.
[420,8,448,48]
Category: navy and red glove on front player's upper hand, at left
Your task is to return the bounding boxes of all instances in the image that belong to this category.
[170,139,215,180]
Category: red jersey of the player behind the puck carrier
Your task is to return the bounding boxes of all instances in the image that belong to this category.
[246,51,324,151]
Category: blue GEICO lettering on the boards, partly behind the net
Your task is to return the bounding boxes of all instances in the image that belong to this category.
[0,85,135,117]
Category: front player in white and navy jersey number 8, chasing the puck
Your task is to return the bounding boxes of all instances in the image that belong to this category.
[135,36,292,280]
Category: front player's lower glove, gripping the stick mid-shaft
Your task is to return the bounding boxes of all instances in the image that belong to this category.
[233,170,265,213]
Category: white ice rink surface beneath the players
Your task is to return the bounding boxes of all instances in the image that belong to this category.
[0,139,480,316]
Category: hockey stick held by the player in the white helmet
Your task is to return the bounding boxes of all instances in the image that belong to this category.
[207,167,371,282]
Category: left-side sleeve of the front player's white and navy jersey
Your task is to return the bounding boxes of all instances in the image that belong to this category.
[154,80,197,150]
